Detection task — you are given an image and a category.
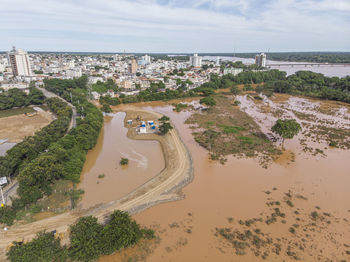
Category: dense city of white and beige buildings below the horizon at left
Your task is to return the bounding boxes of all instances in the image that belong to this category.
[0,47,266,99]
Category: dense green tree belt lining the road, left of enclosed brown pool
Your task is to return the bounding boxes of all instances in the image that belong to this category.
[0,77,103,224]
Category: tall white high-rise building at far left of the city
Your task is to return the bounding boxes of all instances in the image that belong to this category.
[8,47,32,77]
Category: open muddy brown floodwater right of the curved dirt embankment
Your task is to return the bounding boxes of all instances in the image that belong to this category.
[100,100,350,262]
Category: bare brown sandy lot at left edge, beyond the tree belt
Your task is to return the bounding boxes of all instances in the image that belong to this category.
[0,112,52,143]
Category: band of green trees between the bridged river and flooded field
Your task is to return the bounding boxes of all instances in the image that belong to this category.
[194,70,350,103]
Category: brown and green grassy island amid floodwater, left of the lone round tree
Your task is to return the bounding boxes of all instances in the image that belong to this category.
[186,95,279,166]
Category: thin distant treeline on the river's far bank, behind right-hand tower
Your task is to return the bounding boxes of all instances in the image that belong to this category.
[231,52,350,63]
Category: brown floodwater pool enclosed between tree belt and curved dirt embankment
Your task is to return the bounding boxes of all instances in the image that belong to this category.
[81,112,164,208]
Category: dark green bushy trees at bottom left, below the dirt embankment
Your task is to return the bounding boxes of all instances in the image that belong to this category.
[7,210,154,262]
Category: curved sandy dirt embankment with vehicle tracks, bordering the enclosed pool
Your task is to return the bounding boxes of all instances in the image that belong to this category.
[0,107,193,259]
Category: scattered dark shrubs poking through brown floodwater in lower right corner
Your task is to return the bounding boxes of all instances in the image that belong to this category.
[215,191,349,261]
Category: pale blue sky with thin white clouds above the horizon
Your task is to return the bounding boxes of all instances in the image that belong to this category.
[0,0,350,53]
